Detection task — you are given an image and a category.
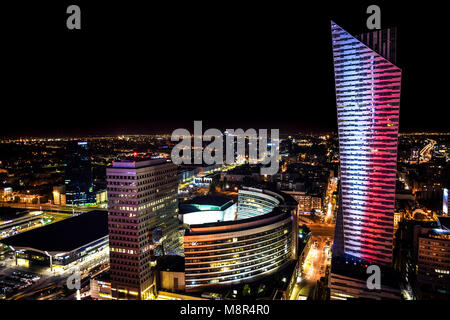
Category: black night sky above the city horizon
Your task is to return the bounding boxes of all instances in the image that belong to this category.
[0,0,450,136]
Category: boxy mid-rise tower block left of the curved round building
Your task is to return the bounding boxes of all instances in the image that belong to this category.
[106,159,182,299]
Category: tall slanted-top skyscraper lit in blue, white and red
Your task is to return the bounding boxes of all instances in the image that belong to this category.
[331,22,402,266]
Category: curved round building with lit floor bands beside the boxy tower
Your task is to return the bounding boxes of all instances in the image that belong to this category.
[184,188,298,292]
